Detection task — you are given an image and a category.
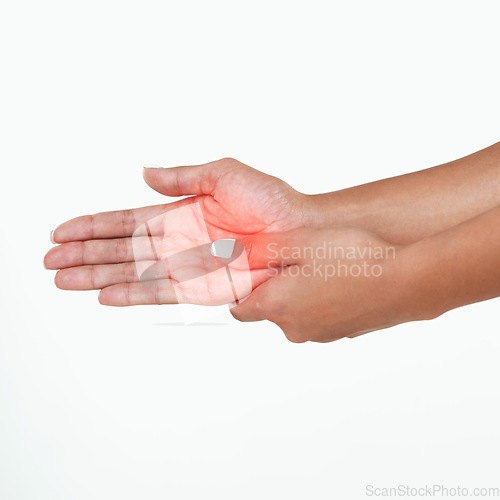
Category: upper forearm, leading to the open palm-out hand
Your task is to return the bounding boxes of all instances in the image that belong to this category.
[305,143,500,244]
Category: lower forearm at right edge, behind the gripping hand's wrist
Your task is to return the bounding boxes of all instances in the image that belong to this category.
[394,206,500,319]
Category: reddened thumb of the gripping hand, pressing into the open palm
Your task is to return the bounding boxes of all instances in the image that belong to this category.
[238,231,304,269]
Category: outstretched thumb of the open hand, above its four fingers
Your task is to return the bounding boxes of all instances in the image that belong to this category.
[144,158,241,196]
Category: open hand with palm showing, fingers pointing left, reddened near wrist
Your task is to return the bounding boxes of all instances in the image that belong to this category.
[44,159,307,306]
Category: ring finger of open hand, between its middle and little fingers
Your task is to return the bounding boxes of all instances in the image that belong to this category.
[54,261,160,290]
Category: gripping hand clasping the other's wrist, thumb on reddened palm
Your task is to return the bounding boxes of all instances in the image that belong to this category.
[231,229,416,342]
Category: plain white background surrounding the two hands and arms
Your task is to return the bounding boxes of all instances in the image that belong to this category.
[0,0,500,500]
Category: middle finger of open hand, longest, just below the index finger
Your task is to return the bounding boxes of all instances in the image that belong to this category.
[44,236,162,269]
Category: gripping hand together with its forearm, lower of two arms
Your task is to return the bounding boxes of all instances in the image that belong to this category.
[231,207,500,342]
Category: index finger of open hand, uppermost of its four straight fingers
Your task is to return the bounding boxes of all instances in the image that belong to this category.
[51,198,196,243]
